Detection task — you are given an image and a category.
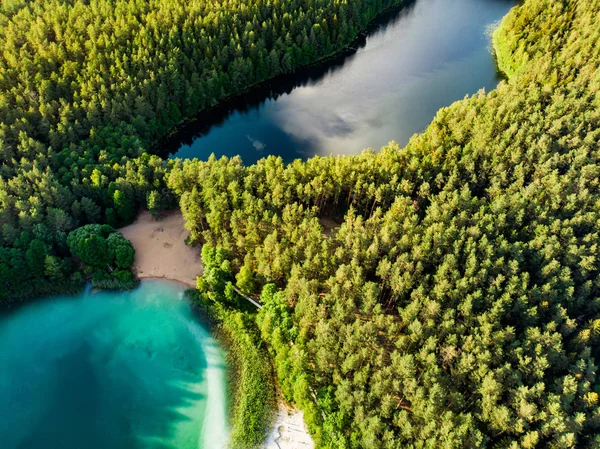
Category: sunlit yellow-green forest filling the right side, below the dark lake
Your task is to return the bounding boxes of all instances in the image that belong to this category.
[168,0,600,449]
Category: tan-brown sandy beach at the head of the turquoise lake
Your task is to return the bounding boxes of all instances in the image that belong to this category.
[119,211,203,287]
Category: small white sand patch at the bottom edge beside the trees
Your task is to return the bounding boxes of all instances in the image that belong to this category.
[263,401,315,449]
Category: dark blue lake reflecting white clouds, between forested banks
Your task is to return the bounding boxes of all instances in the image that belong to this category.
[168,0,517,163]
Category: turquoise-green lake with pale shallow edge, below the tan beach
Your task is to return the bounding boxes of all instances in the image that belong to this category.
[0,281,228,449]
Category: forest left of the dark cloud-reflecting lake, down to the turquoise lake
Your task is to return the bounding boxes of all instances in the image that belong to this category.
[0,0,401,299]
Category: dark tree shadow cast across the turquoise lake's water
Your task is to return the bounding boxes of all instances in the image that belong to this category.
[13,341,213,449]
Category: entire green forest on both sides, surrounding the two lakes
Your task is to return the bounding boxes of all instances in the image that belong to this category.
[0,0,600,449]
